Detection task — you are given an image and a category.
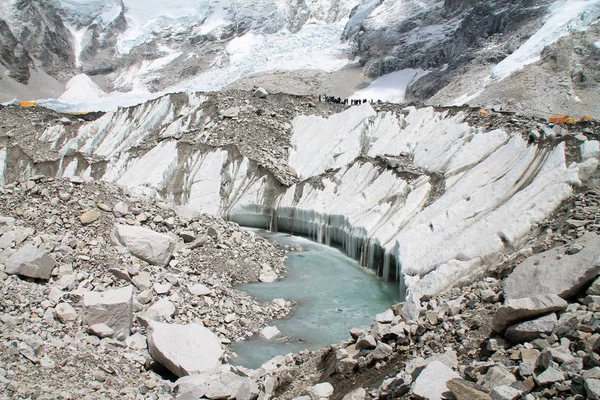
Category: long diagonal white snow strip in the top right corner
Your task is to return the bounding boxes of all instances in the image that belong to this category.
[491,0,600,79]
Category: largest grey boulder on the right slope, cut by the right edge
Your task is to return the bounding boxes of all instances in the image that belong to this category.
[504,232,600,299]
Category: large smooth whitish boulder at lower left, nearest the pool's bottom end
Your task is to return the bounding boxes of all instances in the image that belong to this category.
[147,322,223,376]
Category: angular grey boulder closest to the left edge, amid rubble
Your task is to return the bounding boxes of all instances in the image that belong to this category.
[4,243,56,279]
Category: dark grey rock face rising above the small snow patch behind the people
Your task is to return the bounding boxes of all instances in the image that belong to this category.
[348,0,550,101]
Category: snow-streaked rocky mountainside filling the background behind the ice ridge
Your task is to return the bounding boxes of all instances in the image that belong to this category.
[0,0,600,118]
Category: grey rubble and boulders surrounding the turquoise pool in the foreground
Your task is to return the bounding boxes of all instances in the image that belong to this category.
[0,91,600,400]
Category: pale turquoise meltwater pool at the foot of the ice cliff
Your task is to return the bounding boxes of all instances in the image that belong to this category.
[230,231,398,368]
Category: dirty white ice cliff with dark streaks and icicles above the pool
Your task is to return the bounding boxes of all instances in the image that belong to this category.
[5,94,599,318]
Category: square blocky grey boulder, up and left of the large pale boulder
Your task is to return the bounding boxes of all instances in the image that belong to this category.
[83,286,133,336]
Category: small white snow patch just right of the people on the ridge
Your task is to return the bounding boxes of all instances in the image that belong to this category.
[350,69,429,103]
